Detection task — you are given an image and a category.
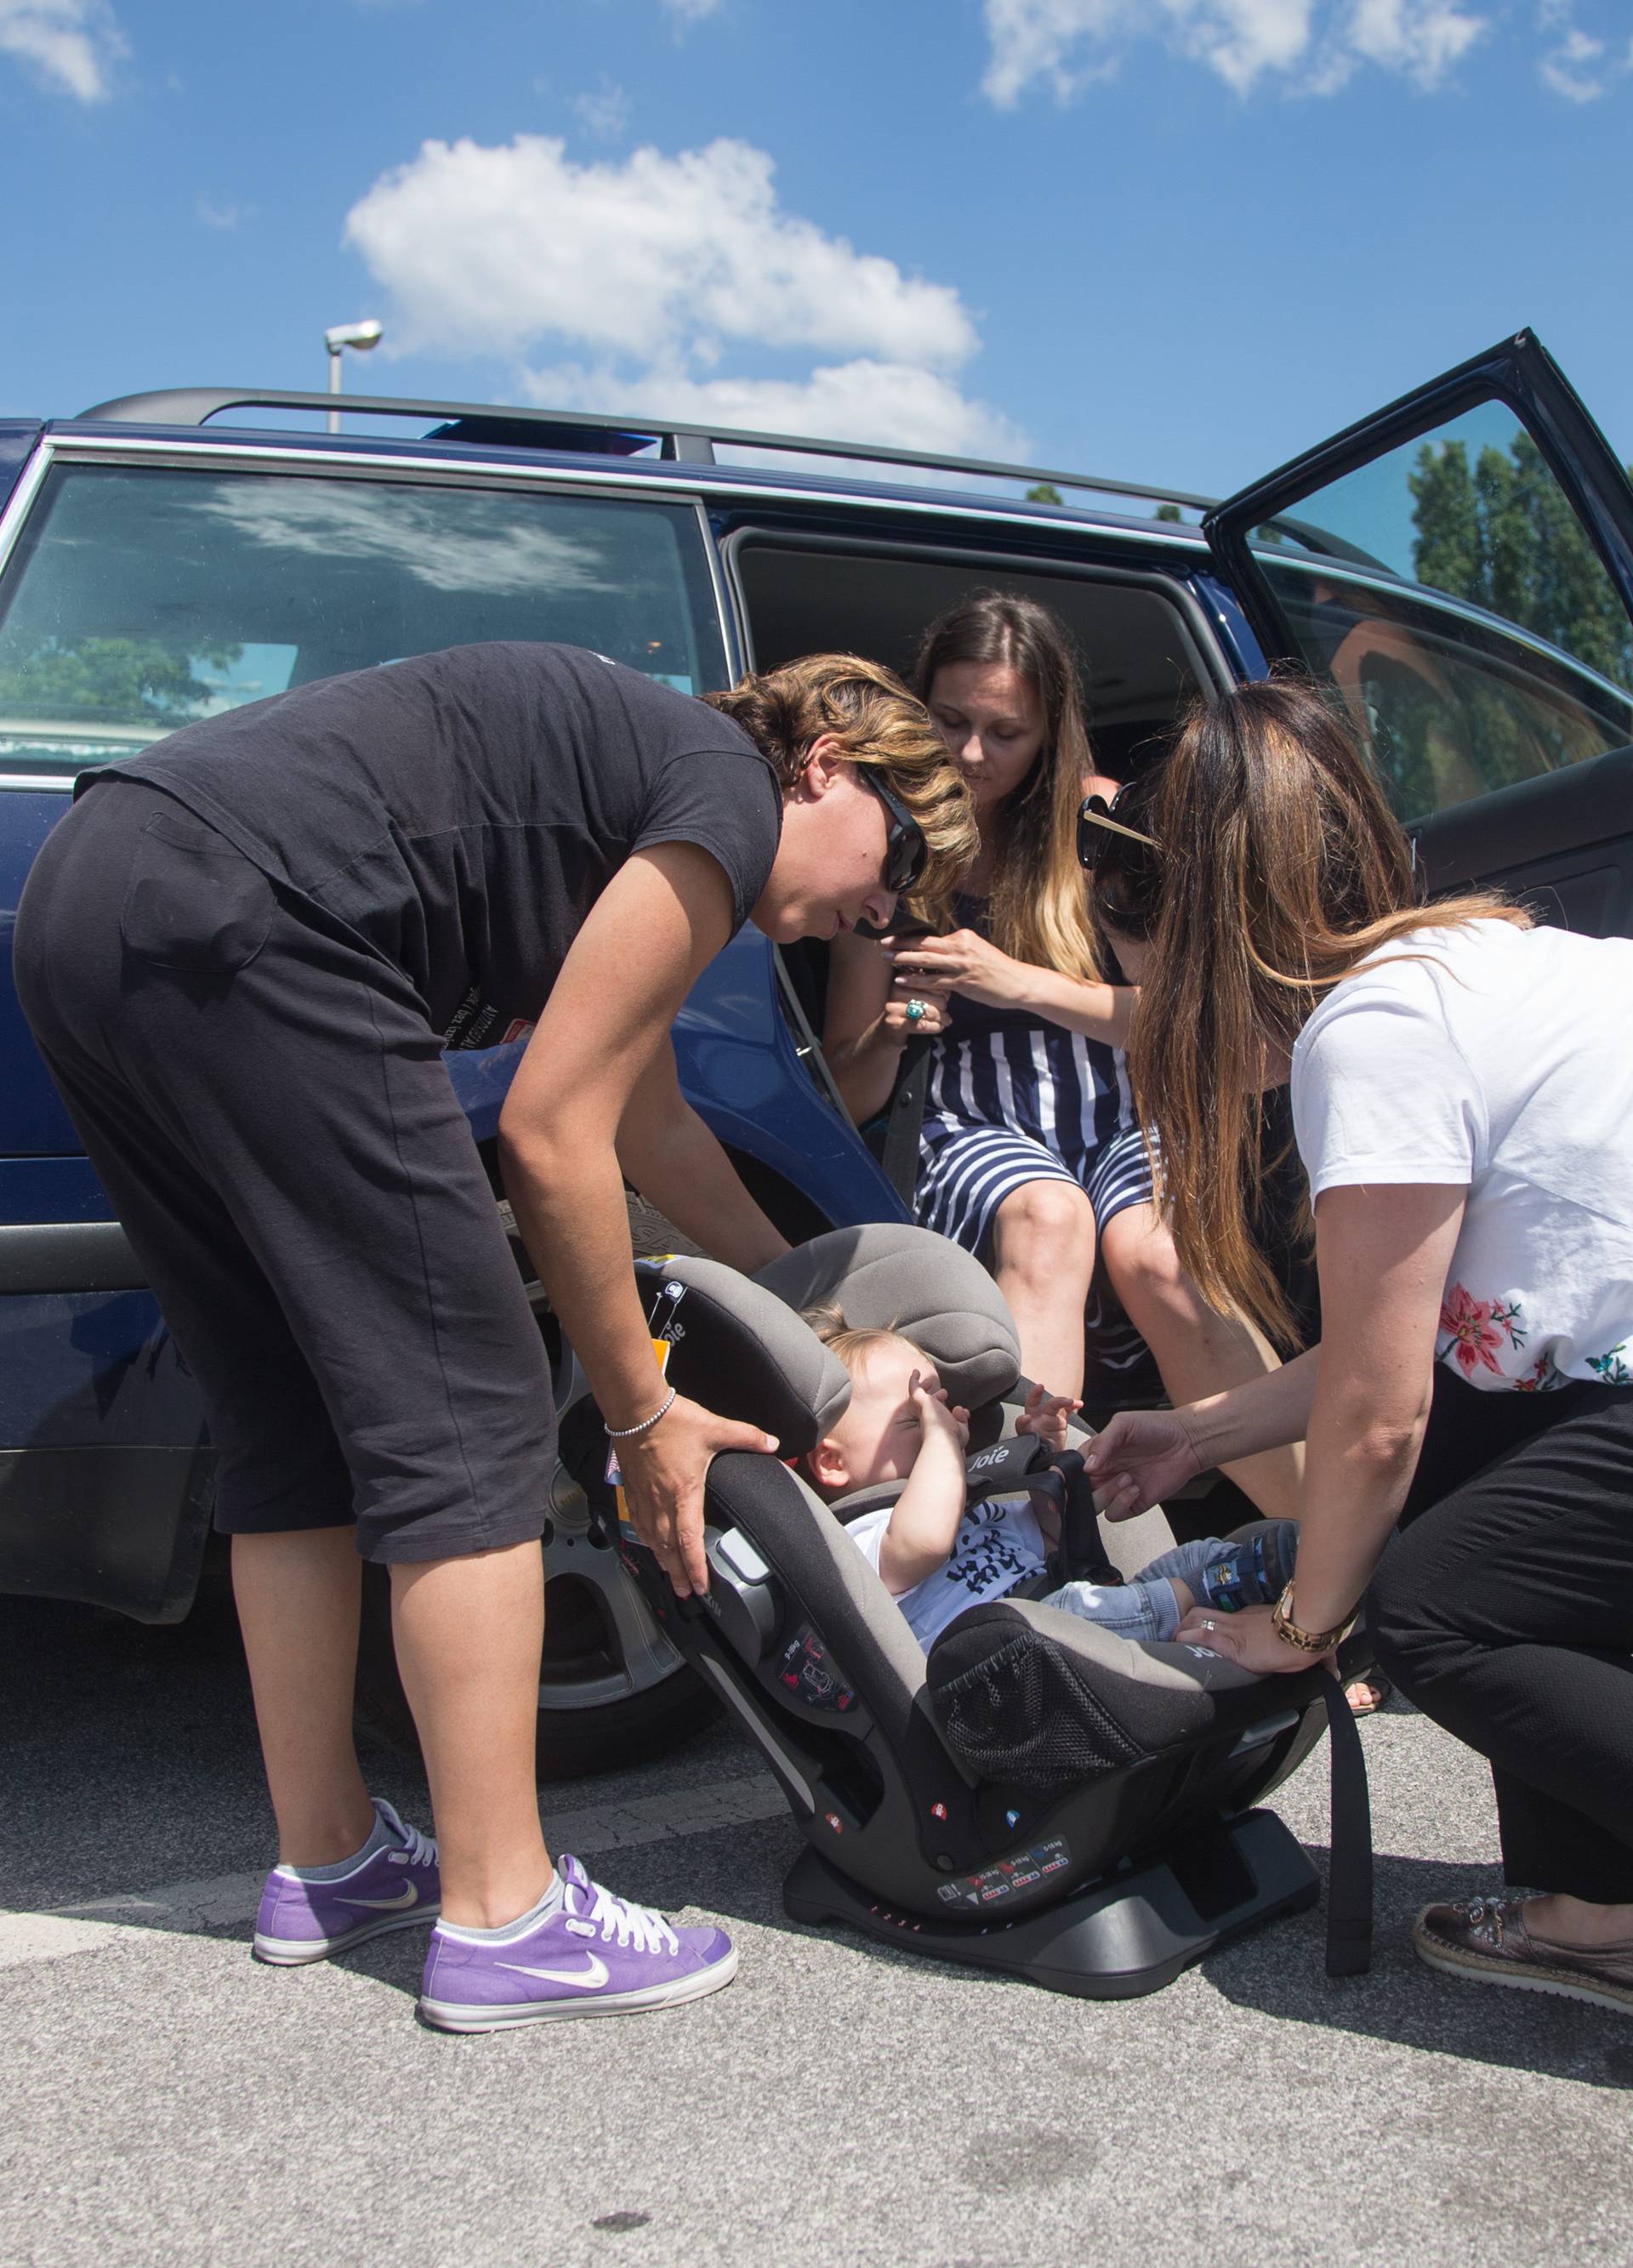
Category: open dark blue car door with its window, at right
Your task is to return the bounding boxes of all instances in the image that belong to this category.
[1204,331,1633,935]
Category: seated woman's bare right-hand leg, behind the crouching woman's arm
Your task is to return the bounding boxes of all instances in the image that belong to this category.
[1102,1204,1304,1520]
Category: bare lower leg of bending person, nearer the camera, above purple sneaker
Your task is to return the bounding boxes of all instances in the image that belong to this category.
[392,1543,554,1930]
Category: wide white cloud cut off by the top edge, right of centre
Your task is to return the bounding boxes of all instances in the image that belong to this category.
[982,0,1490,109]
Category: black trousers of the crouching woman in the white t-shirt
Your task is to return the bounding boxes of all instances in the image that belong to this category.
[1368,1366,1633,1905]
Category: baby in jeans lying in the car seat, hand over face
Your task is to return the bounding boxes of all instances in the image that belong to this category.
[800,1306,1297,1653]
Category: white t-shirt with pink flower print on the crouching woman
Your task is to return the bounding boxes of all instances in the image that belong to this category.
[1293,921,1633,1393]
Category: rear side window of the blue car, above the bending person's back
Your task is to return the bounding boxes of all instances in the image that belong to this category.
[0,465,725,773]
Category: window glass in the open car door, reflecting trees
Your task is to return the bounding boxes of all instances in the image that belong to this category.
[1249,401,1633,819]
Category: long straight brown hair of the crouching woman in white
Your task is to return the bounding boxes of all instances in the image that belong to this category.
[1129,676,1531,1347]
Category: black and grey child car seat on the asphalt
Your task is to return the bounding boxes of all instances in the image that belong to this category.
[562,1225,1370,1998]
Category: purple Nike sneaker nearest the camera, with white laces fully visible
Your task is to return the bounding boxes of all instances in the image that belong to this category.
[419,1850,737,2032]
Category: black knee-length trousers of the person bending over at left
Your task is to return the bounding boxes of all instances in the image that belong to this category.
[14,780,555,1560]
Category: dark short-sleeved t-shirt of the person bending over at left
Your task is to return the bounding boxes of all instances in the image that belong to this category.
[102,644,782,1048]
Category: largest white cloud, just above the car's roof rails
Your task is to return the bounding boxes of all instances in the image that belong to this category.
[347,136,1025,453]
